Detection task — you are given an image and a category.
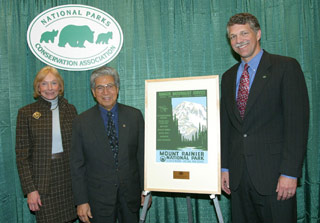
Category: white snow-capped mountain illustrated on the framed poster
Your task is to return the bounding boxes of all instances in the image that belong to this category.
[172,101,207,140]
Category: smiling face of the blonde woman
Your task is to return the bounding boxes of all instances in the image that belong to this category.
[39,73,61,100]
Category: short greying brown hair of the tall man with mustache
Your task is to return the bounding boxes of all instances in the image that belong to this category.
[227,13,260,32]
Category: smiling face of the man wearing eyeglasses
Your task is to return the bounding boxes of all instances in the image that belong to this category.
[91,75,119,111]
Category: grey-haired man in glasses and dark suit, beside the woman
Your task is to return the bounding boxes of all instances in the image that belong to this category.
[71,67,144,223]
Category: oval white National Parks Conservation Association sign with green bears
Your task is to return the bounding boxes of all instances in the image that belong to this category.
[27,5,123,71]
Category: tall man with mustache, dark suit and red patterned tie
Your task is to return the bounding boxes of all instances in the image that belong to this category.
[221,13,309,223]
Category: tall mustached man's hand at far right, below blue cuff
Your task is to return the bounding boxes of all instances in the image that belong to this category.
[276,176,298,200]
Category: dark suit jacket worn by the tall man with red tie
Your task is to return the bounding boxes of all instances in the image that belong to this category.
[221,51,309,195]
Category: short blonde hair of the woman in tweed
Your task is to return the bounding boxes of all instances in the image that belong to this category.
[33,66,64,98]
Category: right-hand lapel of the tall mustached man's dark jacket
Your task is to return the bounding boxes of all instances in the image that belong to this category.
[244,51,271,117]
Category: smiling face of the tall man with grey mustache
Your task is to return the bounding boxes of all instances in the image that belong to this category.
[228,23,261,63]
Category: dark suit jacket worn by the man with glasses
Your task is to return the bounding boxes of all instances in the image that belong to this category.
[71,104,144,215]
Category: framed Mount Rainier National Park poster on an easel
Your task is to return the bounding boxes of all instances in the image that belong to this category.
[144,75,221,194]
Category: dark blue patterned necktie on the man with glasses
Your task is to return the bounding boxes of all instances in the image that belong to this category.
[107,111,119,166]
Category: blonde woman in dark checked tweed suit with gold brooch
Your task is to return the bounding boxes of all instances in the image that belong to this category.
[16,66,77,223]
